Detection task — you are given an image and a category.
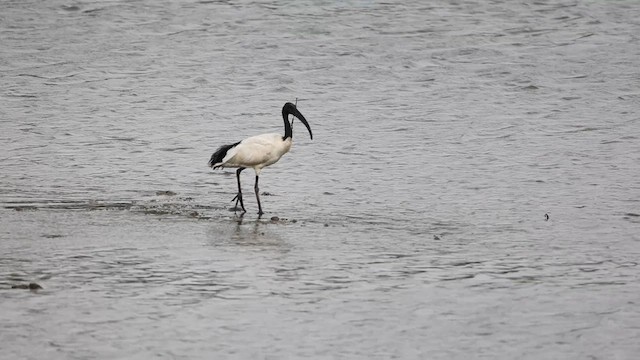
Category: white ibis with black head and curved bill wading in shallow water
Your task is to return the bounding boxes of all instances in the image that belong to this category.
[208,102,313,218]
